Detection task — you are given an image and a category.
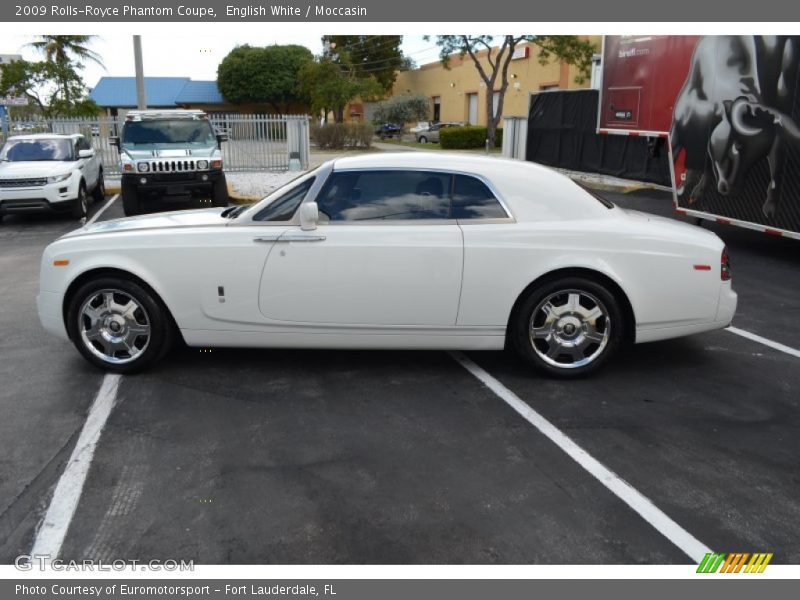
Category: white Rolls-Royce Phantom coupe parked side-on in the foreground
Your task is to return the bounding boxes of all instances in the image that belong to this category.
[38,152,736,376]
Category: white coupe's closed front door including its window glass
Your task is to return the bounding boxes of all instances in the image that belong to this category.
[259,170,463,326]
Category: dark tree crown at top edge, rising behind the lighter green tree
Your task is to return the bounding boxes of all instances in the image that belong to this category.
[322,35,404,92]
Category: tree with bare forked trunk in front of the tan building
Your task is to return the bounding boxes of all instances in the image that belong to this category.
[436,35,595,146]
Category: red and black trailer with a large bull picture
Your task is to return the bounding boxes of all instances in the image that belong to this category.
[597,36,800,239]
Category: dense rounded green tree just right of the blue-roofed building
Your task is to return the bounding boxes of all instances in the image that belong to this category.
[217,44,314,114]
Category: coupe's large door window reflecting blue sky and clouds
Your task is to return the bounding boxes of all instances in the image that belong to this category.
[317,171,452,221]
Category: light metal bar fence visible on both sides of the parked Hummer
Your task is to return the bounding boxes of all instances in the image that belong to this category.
[0,114,309,175]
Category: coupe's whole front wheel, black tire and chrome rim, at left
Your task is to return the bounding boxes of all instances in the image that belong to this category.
[67,277,175,373]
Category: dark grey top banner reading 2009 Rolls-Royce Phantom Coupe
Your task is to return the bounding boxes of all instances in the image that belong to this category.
[0,0,800,21]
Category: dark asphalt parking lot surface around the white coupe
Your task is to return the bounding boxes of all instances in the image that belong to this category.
[0,192,800,564]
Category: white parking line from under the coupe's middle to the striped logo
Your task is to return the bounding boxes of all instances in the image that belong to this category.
[451,352,711,563]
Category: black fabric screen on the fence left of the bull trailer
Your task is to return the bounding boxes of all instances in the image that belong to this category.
[525,90,672,186]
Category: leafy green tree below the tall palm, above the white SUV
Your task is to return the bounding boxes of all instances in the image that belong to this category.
[0,60,100,118]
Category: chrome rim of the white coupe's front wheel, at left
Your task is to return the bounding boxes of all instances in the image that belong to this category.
[78,289,150,365]
